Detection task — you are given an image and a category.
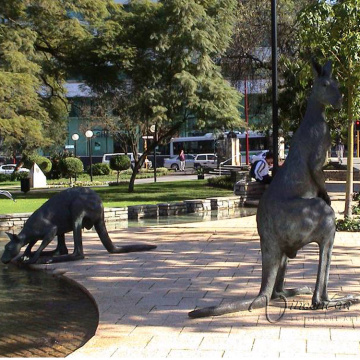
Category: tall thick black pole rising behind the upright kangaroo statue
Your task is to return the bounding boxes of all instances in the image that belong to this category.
[271,0,279,175]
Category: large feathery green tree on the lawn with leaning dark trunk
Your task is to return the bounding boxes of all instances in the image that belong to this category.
[84,0,243,191]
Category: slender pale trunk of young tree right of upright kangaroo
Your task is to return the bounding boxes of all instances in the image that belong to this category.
[344,86,354,218]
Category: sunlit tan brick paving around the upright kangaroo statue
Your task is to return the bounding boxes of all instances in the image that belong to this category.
[28,194,360,359]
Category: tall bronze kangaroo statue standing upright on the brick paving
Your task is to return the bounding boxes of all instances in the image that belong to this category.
[189,58,352,318]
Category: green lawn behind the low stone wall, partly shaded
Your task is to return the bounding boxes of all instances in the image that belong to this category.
[0,180,233,214]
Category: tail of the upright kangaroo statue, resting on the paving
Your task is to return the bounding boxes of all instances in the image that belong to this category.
[188,295,267,319]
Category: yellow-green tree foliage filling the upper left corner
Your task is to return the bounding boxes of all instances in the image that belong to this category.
[0,0,114,158]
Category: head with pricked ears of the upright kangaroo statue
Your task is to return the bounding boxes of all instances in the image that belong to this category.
[311,60,342,109]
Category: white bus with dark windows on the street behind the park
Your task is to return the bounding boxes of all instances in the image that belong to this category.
[170,131,269,162]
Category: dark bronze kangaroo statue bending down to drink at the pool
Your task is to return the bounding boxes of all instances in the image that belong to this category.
[1,187,156,264]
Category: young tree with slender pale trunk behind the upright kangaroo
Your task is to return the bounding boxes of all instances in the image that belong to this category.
[299,0,360,217]
